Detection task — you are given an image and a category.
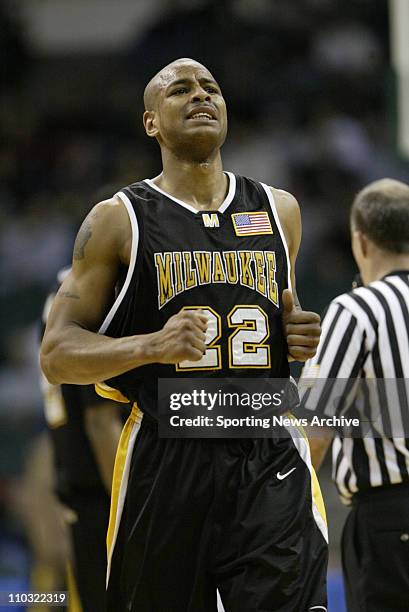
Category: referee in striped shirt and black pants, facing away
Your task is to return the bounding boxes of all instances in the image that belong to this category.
[300,179,409,612]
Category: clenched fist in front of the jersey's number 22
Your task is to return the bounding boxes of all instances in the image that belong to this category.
[151,309,208,363]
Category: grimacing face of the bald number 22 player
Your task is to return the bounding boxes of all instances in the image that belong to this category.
[144,63,227,155]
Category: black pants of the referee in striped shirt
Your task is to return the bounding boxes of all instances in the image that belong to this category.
[342,484,409,612]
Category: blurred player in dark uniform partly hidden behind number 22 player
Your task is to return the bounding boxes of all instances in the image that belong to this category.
[42,268,125,612]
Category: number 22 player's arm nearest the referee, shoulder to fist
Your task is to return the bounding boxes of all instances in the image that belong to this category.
[271,188,321,361]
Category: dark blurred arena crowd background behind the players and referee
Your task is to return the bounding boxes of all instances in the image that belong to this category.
[0,0,409,612]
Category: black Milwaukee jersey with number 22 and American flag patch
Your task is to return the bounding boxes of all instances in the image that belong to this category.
[100,173,291,417]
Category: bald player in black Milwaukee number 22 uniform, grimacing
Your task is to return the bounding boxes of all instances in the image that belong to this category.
[42,59,327,612]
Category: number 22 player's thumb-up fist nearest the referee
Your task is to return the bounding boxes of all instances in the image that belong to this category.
[282,289,321,361]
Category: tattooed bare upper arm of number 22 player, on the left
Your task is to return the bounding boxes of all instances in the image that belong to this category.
[46,200,131,334]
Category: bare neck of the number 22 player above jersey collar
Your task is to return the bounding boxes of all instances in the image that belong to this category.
[154,152,229,210]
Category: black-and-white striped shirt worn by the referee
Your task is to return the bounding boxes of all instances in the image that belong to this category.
[300,270,409,503]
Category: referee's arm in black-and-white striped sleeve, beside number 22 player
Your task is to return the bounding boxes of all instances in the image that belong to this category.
[299,300,366,470]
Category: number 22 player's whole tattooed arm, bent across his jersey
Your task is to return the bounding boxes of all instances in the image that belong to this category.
[41,197,207,384]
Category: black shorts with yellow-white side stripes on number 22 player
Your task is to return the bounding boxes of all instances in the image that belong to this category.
[107,409,327,612]
